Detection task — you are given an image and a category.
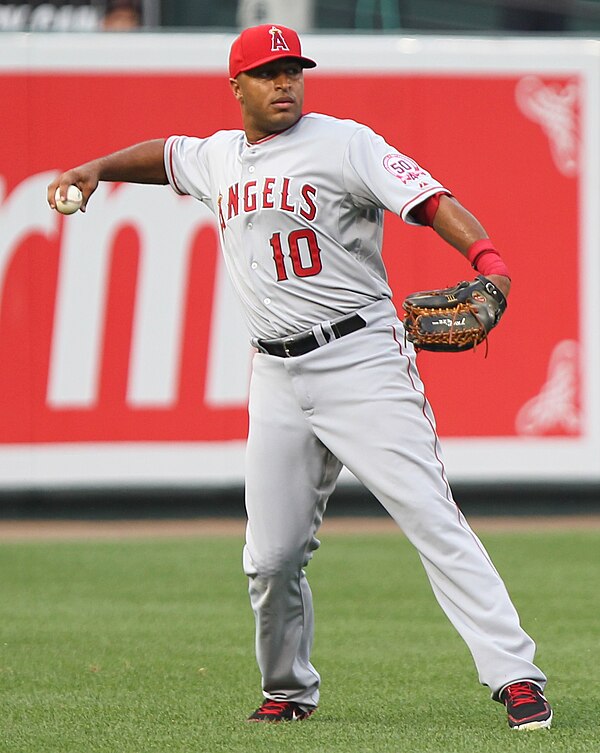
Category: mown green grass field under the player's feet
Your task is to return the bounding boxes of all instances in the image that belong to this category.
[0,530,600,753]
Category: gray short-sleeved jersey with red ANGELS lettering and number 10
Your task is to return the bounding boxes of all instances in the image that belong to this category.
[165,114,445,338]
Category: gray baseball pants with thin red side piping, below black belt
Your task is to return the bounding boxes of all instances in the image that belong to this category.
[244,300,546,706]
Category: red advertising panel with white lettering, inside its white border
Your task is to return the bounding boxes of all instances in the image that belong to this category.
[0,32,598,484]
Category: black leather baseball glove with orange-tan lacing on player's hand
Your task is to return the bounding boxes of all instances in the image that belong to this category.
[402,275,506,353]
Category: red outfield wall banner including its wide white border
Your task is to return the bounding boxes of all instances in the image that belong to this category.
[0,34,600,500]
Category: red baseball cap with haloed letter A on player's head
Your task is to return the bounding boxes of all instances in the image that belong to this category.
[229,24,317,78]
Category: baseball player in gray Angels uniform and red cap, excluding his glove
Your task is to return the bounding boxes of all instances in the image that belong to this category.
[48,24,552,729]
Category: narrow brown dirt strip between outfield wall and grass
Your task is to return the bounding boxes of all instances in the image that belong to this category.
[0,515,600,541]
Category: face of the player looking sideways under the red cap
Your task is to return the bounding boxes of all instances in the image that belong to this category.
[229,58,304,141]
